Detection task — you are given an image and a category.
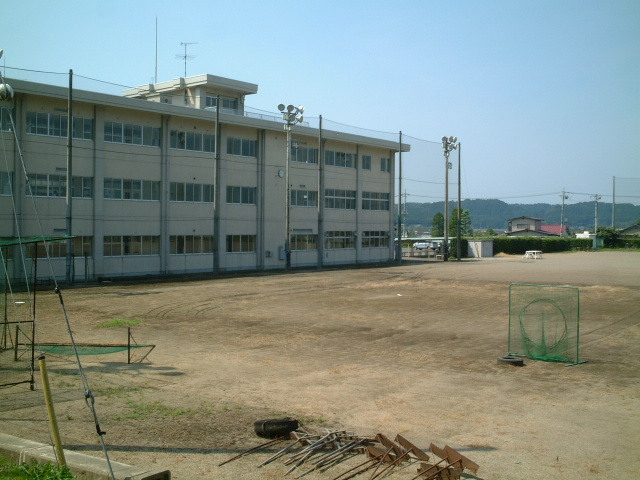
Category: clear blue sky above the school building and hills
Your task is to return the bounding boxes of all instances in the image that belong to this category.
[0,0,640,203]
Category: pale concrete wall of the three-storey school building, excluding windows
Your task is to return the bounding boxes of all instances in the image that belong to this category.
[0,76,404,278]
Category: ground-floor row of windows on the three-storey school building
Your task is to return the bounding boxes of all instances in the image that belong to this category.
[3,231,389,258]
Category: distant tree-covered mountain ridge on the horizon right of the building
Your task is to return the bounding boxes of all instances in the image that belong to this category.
[405,200,640,231]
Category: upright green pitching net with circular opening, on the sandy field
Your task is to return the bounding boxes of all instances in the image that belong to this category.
[507,283,580,363]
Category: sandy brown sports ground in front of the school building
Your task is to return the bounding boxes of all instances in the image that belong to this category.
[0,252,640,480]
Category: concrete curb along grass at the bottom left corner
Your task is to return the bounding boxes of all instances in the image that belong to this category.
[0,433,171,480]
